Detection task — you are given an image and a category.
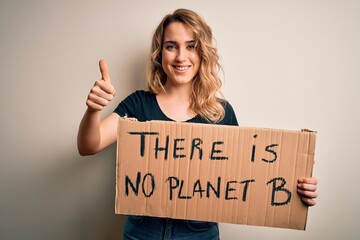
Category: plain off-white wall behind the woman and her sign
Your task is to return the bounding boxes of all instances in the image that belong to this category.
[0,0,360,240]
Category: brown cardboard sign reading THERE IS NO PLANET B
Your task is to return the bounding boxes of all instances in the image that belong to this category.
[115,119,316,230]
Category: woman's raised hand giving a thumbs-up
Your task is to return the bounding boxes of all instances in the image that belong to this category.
[86,60,115,111]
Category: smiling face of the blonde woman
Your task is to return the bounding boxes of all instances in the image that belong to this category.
[162,22,200,86]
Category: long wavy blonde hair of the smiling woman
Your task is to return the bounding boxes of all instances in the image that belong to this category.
[147,9,225,123]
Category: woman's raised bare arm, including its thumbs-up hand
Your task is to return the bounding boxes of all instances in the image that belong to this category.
[77,60,118,156]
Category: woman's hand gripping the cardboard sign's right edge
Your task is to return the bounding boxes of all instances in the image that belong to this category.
[297,177,318,207]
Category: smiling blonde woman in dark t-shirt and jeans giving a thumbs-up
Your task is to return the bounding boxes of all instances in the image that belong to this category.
[78,9,317,239]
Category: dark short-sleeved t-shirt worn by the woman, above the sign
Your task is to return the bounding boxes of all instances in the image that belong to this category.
[114,90,238,126]
